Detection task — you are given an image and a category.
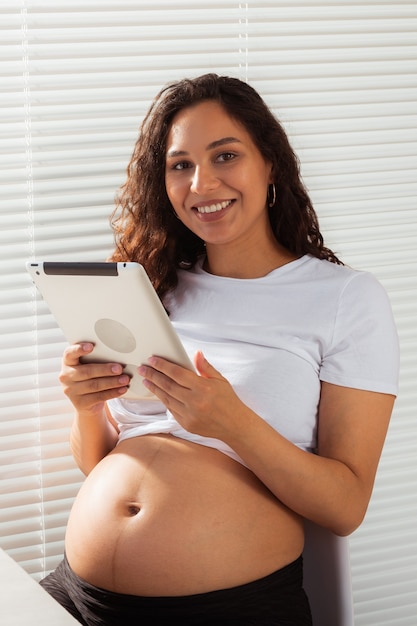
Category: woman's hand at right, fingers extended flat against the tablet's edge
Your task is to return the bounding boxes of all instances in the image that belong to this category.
[138,352,247,441]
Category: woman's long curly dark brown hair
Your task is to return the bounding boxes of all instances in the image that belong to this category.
[111,74,341,298]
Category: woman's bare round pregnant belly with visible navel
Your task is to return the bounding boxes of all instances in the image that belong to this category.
[66,435,303,596]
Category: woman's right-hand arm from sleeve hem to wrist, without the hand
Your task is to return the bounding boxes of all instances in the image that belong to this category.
[223,383,394,535]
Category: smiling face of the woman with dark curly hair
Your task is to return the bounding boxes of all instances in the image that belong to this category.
[165,100,271,250]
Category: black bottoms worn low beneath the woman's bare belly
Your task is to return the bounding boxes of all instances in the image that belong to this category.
[41,557,312,626]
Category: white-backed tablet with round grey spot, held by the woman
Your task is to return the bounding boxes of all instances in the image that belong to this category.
[26,261,195,399]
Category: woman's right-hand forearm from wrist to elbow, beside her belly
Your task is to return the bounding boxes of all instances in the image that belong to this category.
[227,410,370,535]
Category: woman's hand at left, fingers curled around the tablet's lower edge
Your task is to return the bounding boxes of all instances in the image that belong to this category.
[59,342,130,414]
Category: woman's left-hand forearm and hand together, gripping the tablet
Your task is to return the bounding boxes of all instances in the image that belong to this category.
[59,343,129,474]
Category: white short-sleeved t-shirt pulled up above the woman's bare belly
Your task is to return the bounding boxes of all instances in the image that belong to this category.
[109,255,399,462]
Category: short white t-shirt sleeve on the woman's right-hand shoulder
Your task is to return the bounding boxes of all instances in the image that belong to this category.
[320,272,399,395]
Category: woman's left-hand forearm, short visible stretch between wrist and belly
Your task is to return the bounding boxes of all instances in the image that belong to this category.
[70,409,118,474]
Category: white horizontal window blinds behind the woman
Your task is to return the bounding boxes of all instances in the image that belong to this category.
[0,0,417,626]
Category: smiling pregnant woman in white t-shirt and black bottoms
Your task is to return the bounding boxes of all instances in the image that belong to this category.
[42,74,398,626]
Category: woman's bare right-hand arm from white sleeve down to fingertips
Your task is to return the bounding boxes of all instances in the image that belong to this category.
[140,353,394,535]
